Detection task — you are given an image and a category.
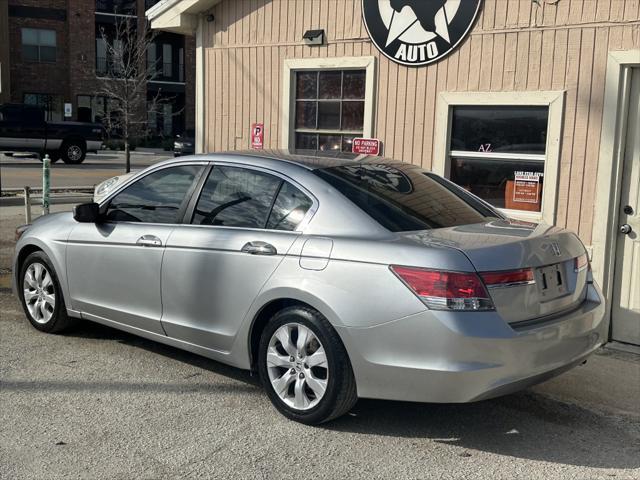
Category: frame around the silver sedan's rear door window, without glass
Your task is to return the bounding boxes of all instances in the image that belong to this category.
[181,161,320,234]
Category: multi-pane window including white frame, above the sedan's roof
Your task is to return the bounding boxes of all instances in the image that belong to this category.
[282,57,375,152]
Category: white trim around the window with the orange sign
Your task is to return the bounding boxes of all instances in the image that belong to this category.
[432,91,565,225]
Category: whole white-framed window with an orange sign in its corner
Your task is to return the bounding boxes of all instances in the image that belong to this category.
[432,92,564,224]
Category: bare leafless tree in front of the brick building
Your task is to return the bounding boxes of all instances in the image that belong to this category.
[98,17,174,173]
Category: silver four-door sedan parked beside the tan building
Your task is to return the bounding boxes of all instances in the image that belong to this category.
[13,151,608,424]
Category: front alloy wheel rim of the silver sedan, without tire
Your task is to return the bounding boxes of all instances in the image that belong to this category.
[22,262,56,324]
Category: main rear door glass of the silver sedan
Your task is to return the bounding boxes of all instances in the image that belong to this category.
[192,166,282,228]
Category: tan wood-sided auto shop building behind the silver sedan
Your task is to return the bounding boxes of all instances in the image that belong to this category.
[147,0,640,344]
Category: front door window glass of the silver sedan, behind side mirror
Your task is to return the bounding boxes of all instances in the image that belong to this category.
[107,165,202,223]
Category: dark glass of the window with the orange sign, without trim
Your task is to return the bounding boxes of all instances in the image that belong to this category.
[450,106,549,212]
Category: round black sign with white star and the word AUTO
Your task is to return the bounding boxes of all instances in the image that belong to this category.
[362,0,482,67]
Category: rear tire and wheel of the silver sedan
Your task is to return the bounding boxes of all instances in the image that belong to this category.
[258,306,358,425]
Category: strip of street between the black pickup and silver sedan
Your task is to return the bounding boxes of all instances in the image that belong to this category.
[0,151,173,189]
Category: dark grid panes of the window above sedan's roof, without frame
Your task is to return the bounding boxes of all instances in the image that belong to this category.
[294,70,366,152]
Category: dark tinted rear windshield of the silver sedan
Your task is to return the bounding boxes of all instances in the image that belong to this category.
[314,164,498,232]
